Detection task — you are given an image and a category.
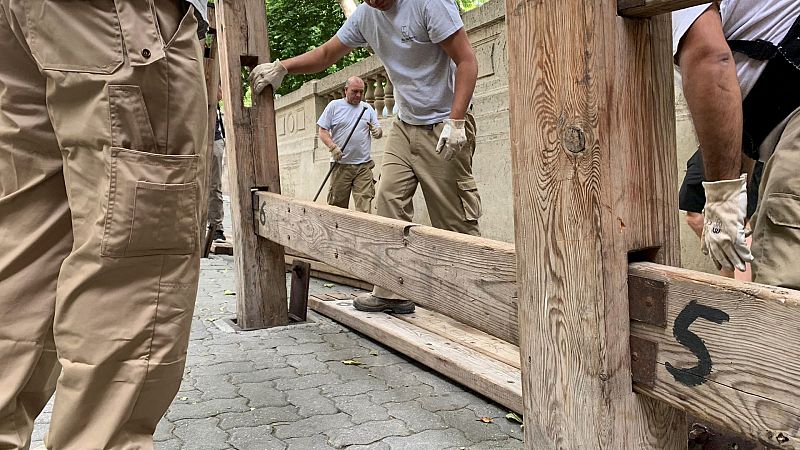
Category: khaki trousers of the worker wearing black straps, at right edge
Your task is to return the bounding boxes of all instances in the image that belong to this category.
[751,109,800,289]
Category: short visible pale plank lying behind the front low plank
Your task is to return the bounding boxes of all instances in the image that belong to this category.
[395,308,520,369]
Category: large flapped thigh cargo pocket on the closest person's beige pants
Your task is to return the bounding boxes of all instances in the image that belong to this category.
[101,147,199,258]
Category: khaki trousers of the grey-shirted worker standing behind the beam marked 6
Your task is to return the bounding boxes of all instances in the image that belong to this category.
[373,114,481,299]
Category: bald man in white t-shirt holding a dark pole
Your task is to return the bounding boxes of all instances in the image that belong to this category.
[317,77,383,213]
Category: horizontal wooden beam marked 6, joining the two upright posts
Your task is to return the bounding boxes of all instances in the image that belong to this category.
[257,192,517,343]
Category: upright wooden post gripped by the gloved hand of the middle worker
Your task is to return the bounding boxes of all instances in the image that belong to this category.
[216,0,289,330]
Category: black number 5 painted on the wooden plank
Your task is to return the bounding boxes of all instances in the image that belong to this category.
[666,300,730,386]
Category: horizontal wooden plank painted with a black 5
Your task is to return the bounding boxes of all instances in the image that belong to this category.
[630,263,800,448]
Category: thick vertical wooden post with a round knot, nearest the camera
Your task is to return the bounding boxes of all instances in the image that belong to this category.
[506,0,686,450]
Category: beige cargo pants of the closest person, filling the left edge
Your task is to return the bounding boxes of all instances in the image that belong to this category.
[0,0,208,450]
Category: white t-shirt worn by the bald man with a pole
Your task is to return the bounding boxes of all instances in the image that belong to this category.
[317,98,380,164]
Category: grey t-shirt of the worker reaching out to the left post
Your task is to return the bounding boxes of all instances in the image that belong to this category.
[336,0,464,125]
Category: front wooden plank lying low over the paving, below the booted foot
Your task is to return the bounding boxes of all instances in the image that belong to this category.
[308,297,522,412]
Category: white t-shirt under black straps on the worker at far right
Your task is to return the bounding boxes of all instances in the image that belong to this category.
[672,0,800,160]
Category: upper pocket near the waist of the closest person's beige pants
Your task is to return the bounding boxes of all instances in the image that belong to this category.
[20,0,123,74]
